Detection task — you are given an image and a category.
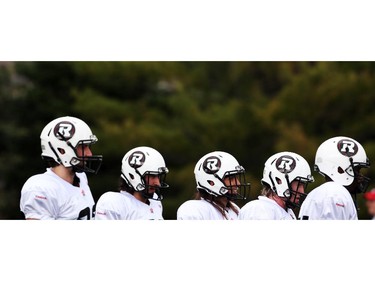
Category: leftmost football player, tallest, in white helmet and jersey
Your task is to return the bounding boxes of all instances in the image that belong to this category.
[20,116,102,220]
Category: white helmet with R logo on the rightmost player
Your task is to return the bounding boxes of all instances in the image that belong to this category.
[314,136,370,193]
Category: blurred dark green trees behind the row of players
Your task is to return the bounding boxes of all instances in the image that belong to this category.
[0,62,375,219]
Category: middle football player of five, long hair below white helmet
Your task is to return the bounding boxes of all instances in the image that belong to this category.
[177,151,250,220]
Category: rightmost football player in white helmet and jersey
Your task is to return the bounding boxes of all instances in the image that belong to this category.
[299,136,370,220]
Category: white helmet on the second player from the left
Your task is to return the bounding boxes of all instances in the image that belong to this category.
[121,146,169,200]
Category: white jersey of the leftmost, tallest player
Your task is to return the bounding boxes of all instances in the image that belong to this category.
[20,168,95,220]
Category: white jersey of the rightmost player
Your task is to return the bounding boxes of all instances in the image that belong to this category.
[299,182,358,220]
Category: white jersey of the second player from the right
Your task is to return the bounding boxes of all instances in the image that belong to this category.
[238,195,296,220]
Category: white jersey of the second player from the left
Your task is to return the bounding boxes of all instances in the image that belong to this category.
[95,191,163,220]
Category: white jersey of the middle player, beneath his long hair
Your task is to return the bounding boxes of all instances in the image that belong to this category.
[177,199,240,220]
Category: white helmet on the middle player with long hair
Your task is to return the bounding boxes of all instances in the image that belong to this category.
[194,151,250,200]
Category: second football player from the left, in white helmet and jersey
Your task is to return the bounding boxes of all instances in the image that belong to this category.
[95,146,168,220]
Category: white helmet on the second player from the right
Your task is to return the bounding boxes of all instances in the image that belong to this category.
[261,151,314,208]
